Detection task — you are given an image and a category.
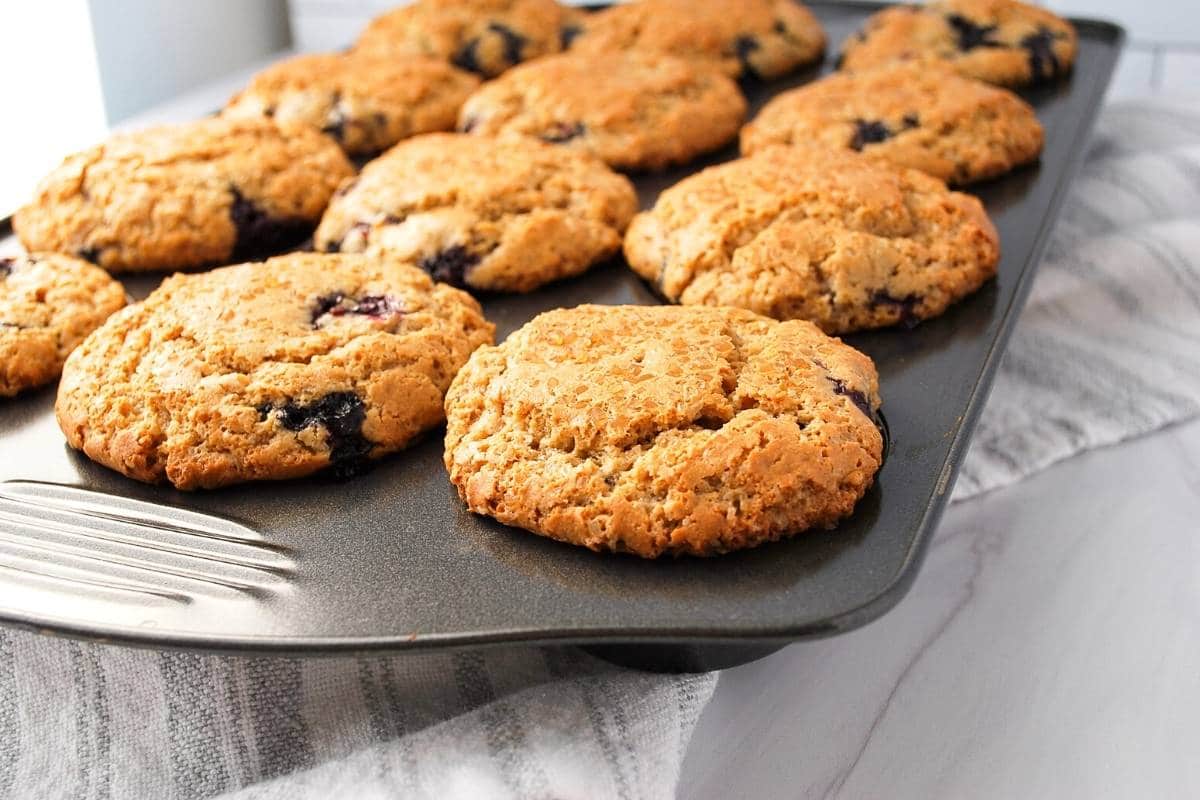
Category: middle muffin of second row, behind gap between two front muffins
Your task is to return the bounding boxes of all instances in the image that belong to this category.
[314,133,637,291]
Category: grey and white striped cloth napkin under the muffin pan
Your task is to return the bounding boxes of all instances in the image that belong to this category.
[0,100,1200,800]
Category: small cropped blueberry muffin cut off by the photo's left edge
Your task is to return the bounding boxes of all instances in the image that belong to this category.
[0,253,125,397]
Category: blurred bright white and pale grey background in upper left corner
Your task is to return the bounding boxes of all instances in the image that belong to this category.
[0,0,292,217]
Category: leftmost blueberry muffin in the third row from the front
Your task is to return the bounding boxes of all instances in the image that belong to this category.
[224,53,479,156]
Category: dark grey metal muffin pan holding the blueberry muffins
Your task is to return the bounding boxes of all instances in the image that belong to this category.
[0,4,1122,669]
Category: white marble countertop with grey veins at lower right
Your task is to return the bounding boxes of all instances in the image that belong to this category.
[679,421,1200,800]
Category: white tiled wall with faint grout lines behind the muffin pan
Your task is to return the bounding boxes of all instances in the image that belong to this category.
[288,0,1200,97]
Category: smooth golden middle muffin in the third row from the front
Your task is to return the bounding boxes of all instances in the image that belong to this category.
[458,52,746,170]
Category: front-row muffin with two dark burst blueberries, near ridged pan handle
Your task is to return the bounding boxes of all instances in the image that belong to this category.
[55,253,493,489]
